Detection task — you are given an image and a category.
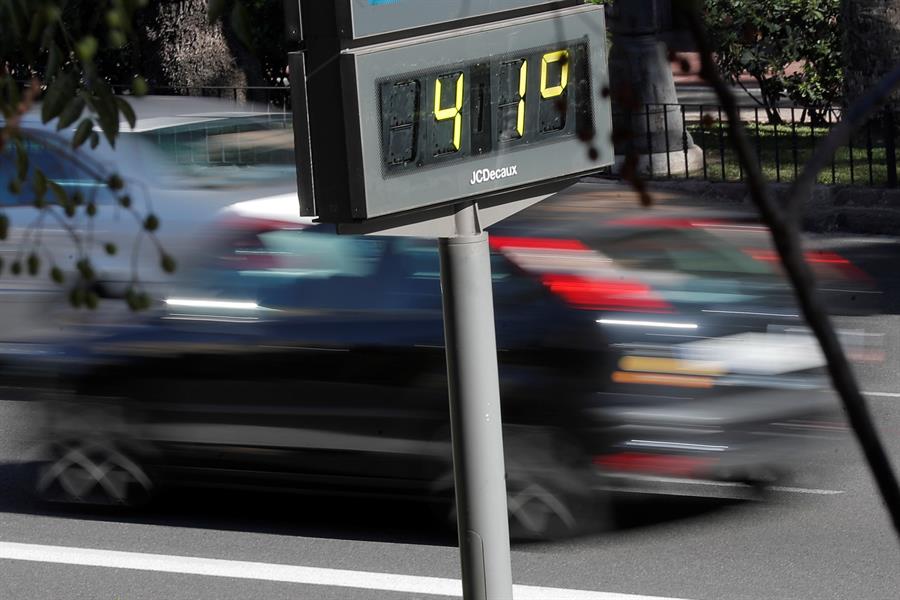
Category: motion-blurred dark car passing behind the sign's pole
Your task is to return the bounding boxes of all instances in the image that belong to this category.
[21,199,839,538]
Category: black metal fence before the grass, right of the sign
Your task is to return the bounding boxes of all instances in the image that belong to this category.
[615,104,900,187]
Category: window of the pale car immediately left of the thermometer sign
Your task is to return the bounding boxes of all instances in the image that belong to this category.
[131,113,296,187]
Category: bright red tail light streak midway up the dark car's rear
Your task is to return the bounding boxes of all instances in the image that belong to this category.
[541,273,672,312]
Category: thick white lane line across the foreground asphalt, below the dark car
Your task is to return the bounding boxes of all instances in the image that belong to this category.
[0,542,692,600]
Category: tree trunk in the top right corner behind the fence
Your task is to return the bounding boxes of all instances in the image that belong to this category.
[842,0,900,111]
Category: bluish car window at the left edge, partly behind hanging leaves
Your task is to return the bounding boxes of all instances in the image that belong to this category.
[0,140,114,206]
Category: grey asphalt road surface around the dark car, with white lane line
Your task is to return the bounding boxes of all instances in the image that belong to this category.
[0,224,900,600]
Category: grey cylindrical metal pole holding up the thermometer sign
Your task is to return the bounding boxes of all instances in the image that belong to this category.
[439,203,512,600]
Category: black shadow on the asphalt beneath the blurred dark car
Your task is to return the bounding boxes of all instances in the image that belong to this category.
[0,463,746,546]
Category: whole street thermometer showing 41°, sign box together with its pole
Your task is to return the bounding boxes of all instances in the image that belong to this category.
[290,0,613,600]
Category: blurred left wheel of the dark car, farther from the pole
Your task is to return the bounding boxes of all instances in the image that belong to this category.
[36,440,154,507]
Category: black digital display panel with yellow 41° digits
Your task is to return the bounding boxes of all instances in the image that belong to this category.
[379,42,594,174]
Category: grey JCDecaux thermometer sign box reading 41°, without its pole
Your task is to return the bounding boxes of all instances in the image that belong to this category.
[291,0,613,223]
